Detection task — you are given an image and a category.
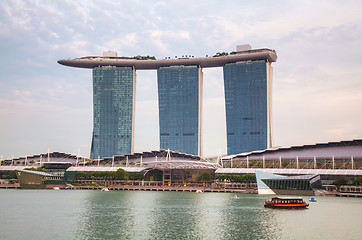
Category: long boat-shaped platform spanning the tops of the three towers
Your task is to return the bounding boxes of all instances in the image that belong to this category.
[58,49,277,70]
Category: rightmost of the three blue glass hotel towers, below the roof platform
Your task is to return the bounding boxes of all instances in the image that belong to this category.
[224,60,271,155]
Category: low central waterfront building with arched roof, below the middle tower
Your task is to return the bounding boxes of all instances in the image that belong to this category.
[67,150,219,186]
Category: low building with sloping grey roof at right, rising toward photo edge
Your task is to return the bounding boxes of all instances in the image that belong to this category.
[221,139,362,171]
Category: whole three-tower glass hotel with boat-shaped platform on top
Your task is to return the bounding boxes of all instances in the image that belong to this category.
[58,45,277,159]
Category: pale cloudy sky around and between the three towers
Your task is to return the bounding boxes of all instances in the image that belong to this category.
[0,0,362,159]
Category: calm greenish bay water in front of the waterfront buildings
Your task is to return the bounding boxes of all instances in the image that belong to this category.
[0,189,362,240]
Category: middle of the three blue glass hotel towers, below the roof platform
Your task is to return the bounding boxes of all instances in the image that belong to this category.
[157,66,202,155]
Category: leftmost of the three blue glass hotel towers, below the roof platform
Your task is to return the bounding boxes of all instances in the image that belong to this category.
[90,67,135,159]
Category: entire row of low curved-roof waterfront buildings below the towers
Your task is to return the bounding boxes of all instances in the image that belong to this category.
[0,143,362,190]
